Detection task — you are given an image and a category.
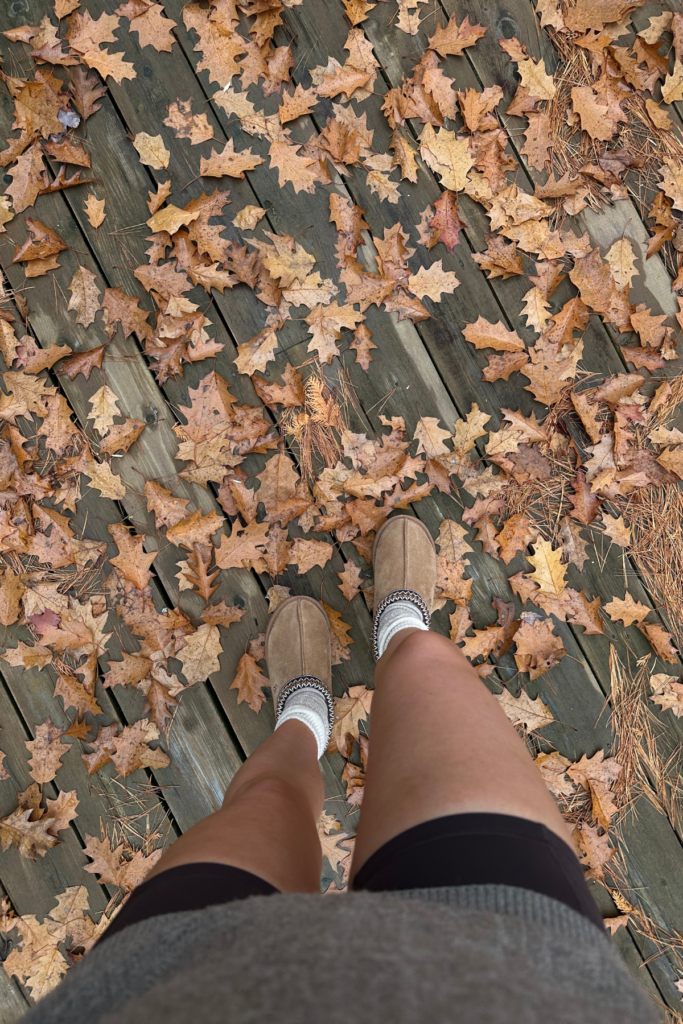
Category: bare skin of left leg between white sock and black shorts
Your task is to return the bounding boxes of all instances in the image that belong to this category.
[147,721,325,892]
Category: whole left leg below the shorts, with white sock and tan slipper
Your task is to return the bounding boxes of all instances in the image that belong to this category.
[147,597,332,892]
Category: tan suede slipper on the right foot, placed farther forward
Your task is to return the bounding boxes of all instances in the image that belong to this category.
[373,515,436,658]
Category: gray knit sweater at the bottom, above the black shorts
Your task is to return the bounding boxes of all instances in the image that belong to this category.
[25,886,658,1024]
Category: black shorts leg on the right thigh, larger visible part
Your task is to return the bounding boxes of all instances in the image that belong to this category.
[353,814,603,928]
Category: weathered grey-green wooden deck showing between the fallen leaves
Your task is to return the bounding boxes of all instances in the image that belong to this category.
[0,0,683,1022]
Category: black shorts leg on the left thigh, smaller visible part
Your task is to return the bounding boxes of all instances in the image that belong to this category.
[99,862,279,942]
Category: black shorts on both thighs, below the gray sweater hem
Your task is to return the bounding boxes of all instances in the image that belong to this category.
[99,814,603,942]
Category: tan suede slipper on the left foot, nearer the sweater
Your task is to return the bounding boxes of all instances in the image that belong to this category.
[265,596,334,728]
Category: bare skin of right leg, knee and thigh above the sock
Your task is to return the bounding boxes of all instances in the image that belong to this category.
[351,629,568,877]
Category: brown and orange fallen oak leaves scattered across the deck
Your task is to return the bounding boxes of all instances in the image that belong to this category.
[0,0,683,997]
